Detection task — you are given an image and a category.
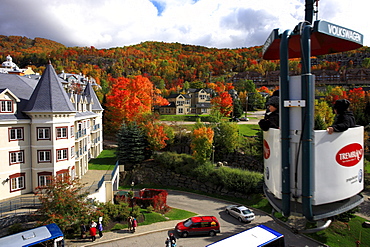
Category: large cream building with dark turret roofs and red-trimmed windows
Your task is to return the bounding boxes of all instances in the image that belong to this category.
[0,61,103,200]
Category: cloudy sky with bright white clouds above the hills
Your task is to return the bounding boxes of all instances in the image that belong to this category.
[0,0,370,49]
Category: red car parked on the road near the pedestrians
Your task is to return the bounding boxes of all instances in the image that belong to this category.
[175,216,220,238]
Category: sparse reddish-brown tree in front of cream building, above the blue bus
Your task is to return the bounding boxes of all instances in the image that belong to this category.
[35,176,102,231]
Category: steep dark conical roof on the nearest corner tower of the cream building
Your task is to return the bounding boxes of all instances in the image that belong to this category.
[24,64,76,112]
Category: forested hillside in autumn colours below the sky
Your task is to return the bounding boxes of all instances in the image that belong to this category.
[0,36,369,96]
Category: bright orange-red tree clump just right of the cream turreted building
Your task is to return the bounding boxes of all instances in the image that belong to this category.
[106,76,169,150]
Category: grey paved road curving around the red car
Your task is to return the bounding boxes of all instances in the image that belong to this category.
[99,191,322,247]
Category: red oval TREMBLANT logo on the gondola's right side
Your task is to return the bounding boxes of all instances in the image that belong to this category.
[335,143,364,167]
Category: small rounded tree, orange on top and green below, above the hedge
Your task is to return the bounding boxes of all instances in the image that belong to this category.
[190,124,214,164]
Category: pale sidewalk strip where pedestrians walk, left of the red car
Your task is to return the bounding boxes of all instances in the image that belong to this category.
[65,220,180,247]
